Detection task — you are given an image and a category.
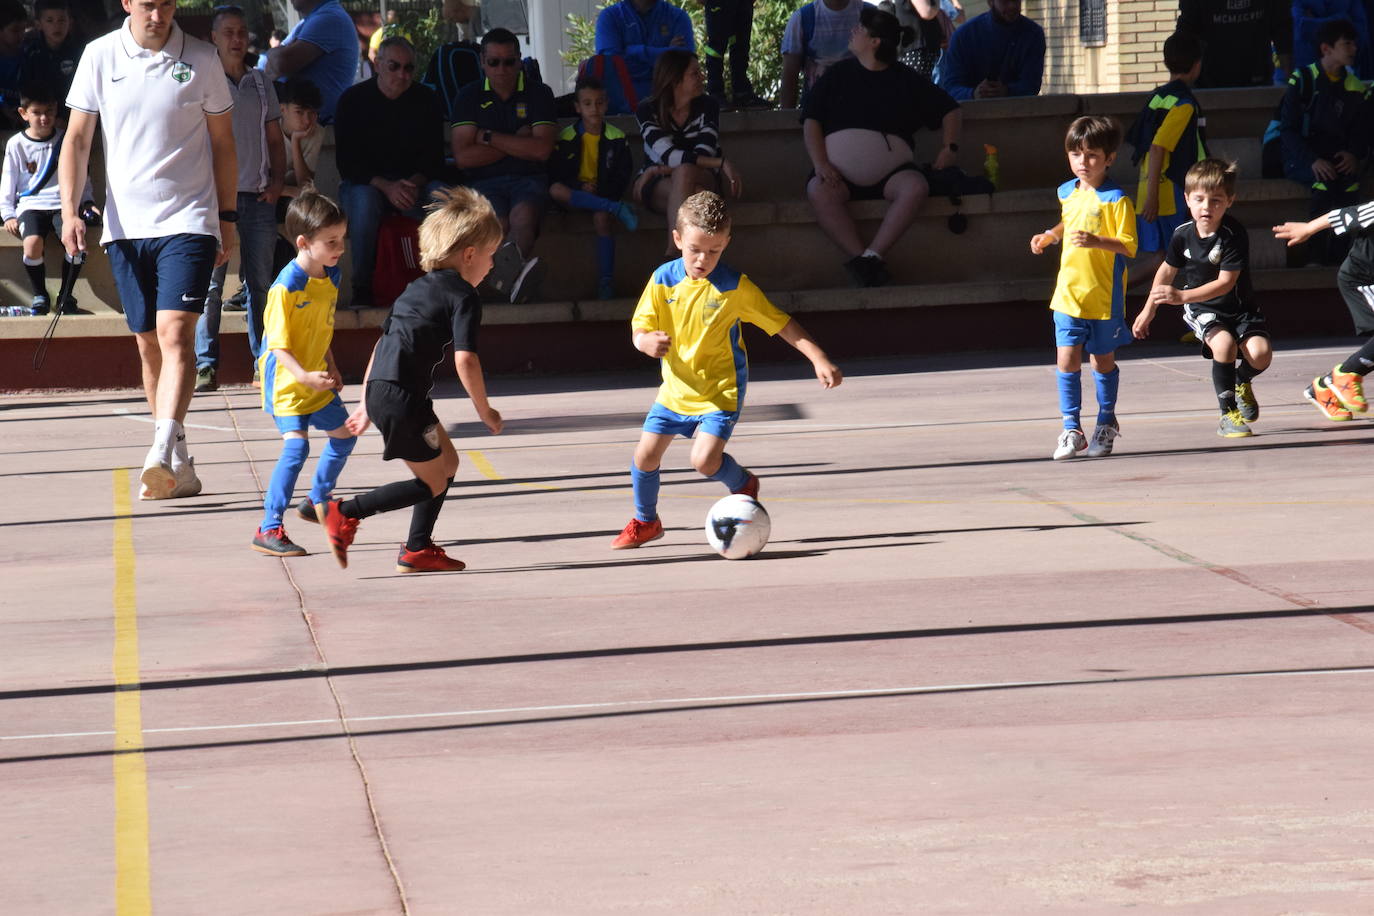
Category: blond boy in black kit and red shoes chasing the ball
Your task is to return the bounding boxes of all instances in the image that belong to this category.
[315,187,502,573]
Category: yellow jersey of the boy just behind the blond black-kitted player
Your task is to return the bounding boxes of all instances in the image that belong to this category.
[258,261,339,416]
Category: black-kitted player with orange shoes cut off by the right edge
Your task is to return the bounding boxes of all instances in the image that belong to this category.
[1274,201,1374,423]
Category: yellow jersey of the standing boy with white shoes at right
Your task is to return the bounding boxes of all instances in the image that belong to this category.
[1050,179,1136,320]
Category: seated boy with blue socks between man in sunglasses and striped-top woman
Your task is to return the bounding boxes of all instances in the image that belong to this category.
[548,77,639,299]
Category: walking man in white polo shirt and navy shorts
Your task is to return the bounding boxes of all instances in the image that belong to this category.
[58,0,238,500]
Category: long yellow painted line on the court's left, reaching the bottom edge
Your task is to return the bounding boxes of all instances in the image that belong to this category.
[114,467,153,916]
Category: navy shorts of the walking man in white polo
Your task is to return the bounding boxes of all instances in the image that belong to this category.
[104,232,220,334]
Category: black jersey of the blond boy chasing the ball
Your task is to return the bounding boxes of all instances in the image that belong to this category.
[368,271,482,397]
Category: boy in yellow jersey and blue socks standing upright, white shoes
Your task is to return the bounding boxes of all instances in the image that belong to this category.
[1031,115,1135,460]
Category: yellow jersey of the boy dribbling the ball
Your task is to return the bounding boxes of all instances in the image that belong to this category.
[631,258,791,416]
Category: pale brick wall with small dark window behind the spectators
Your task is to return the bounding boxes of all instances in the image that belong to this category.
[1021,0,1179,95]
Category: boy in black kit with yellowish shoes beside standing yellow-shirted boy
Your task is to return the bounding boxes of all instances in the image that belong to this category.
[1132,159,1274,438]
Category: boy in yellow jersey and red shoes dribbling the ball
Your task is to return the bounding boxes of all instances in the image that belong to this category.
[610,191,844,551]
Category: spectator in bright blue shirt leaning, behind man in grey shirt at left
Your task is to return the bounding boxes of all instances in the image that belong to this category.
[267,0,359,124]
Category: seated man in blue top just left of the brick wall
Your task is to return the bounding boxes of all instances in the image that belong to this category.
[940,0,1044,100]
